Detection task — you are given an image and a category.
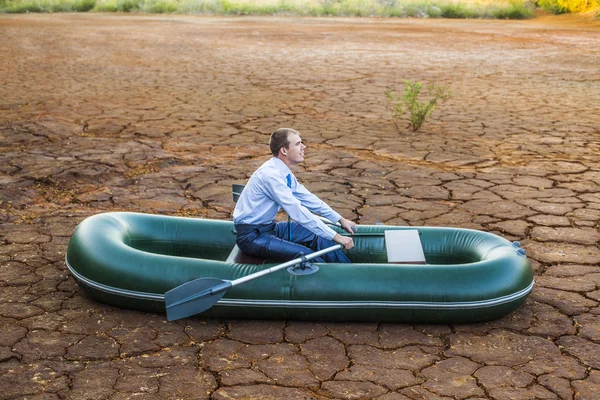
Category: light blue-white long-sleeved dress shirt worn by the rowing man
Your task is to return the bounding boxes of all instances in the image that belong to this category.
[233,157,341,240]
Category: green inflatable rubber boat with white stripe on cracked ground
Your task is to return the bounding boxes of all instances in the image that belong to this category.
[66,212,534,323]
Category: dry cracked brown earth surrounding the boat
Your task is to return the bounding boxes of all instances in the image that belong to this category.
[0,14,600,400]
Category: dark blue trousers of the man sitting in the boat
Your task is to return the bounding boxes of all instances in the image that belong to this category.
[235,222,350,263]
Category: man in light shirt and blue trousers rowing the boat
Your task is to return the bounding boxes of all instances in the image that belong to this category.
[233,128,356,263]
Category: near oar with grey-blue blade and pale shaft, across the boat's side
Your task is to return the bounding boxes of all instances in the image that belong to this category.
[165,244,343,321]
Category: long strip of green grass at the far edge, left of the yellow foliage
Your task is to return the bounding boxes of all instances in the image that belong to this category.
[0,0,540,19]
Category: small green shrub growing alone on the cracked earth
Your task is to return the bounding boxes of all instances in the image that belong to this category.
[385,81,452,132]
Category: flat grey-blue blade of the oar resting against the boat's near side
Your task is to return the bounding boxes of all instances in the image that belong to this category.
[165,278,228,321]
